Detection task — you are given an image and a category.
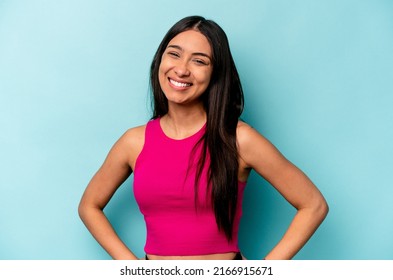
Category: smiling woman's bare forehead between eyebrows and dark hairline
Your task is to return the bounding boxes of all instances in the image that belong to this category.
[167,30,212,56]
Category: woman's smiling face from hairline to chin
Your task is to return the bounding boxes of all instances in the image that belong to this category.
[158,30,213,105]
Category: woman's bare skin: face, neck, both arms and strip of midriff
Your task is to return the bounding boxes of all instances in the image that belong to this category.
[79,30,328,260]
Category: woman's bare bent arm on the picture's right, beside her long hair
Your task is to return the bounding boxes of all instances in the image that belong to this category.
[238,123,328,259]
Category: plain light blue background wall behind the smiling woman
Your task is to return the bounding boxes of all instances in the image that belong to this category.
[0,0,393,259]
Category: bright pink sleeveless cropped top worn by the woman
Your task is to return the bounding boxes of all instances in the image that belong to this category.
[134,118,246,256]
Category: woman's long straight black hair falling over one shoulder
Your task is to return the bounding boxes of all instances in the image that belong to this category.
[150,16,244,240]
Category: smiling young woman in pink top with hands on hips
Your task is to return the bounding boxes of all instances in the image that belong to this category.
[79,16,328,260]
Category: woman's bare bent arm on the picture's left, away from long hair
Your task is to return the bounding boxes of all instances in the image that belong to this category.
[78,126,145,260]
